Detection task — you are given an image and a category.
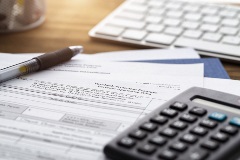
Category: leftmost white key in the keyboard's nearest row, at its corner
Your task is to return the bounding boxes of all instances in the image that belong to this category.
[96,26,124,37]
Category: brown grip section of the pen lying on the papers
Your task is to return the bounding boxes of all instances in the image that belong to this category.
[34,48,73,70]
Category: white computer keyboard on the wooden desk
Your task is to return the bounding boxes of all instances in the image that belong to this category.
[89,0,240,61]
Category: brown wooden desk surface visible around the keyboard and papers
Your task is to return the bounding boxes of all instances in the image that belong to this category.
[0,0,240,80]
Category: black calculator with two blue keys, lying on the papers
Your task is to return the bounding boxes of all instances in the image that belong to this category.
[104,87,240,160]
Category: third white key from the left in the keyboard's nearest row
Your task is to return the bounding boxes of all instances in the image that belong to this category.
[145,33,176,45]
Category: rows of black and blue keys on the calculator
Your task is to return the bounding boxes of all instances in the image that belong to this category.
[113,101,240,160]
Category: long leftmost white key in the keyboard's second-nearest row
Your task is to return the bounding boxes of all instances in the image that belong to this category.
[107,18,145,29]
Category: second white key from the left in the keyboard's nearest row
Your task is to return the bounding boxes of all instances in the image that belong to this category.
[122,29,147,41]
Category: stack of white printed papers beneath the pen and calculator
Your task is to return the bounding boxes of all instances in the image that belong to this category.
[0,49,240,160]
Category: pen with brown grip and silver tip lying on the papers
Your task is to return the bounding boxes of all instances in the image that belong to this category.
[0,46,83,83]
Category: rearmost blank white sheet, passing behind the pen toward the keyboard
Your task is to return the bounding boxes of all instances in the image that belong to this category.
[0,48,200,67]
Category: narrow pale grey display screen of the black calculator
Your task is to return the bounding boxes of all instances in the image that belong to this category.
[192,98,240,115]
